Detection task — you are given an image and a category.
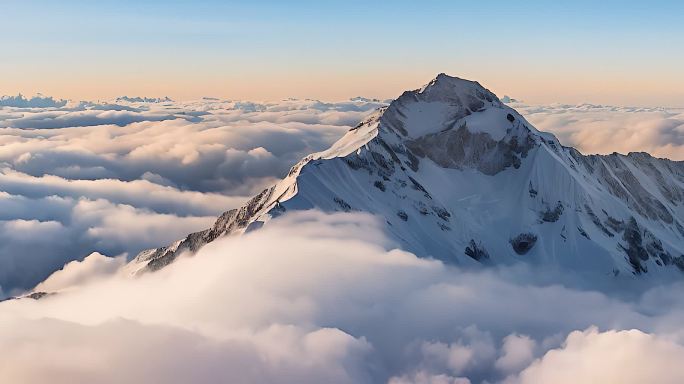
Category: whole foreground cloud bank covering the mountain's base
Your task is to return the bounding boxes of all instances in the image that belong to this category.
[0,211,684,384]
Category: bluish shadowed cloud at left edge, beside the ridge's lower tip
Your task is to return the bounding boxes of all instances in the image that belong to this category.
[0,189,215,295]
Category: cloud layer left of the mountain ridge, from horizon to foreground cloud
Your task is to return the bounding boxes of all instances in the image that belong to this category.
[0,96,381,298]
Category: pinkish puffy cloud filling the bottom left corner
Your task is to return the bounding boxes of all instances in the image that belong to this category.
[0,319,368,384]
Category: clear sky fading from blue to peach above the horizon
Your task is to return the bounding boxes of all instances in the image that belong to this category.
[0,0,684,106]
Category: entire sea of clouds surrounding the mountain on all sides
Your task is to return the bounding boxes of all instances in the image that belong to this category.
[0,96,684,383]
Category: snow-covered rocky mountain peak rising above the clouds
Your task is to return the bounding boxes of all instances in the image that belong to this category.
[127,74,684,275]
